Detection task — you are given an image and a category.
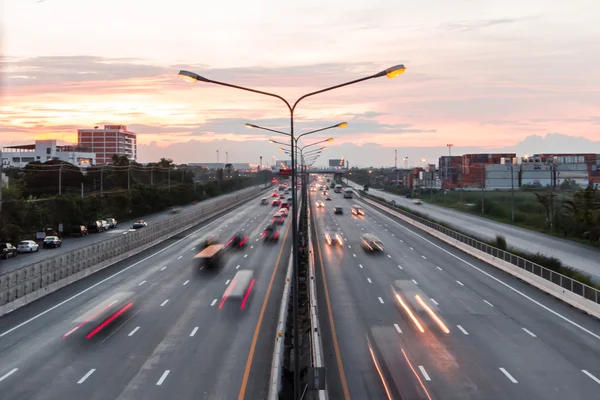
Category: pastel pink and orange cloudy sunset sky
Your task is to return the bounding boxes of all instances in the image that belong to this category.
[0,0,600,165]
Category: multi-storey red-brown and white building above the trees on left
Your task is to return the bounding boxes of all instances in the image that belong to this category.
[77,125,137,165]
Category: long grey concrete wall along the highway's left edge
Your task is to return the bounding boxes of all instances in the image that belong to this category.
[0,188,262,316]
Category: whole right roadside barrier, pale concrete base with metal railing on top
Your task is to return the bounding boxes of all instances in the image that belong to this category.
[357,192,600,318]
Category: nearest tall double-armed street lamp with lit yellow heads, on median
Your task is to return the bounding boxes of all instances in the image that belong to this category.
[178,64,406,400]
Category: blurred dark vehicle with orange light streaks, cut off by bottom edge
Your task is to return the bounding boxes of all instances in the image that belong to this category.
[367,326,434,400]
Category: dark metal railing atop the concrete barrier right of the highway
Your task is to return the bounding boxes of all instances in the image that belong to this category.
[357,193,600,304]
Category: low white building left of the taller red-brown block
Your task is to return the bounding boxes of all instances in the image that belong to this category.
[2,140,96,168]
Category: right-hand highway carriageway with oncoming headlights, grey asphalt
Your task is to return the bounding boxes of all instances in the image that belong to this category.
[311,188,600,400]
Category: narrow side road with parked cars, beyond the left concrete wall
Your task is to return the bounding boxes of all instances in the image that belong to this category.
[0,188,252,273]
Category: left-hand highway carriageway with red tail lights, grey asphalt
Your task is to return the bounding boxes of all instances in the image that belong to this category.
[0,192,291,400]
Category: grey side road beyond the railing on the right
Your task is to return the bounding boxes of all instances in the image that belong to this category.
[350,181,600,282]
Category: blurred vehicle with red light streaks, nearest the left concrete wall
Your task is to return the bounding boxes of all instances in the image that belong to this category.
[63,292,135,339]
